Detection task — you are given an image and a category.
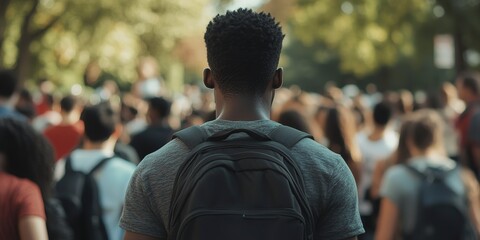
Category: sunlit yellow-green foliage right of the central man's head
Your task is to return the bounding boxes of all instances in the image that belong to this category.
[293,0,431,76]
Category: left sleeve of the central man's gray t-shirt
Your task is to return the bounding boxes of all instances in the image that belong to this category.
[120,163,167,238]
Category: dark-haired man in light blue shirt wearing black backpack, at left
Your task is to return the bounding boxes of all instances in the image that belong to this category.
[55,102,135,240]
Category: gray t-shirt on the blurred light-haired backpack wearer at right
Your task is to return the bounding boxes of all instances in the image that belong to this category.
[380,158,465,234]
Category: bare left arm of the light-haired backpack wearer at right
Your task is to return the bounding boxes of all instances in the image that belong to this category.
[375,198,398,240]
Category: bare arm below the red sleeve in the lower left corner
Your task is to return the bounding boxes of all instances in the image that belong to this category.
[18,216,48,240]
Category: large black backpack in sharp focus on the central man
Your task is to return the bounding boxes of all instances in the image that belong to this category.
[168,126,313,240]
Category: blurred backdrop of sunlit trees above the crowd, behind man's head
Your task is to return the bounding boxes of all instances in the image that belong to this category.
[0,0,480,93]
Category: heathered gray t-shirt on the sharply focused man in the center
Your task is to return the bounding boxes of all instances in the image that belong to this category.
[120,120,364,239]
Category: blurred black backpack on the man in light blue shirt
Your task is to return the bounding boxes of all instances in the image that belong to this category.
[55,157,113,240]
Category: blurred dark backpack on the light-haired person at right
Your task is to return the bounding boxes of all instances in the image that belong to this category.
[405,165,477,240]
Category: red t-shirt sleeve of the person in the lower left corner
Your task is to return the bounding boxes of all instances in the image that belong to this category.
[16,181,46,219]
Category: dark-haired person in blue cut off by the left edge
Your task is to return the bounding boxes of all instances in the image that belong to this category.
[0,70,27,121]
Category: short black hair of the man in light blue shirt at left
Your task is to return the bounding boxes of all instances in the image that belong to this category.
[80,102,119,142]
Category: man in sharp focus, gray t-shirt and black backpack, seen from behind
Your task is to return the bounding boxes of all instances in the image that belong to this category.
[120,9,364,240]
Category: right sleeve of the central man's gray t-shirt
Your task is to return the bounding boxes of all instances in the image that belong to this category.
[316,157,365,240]
